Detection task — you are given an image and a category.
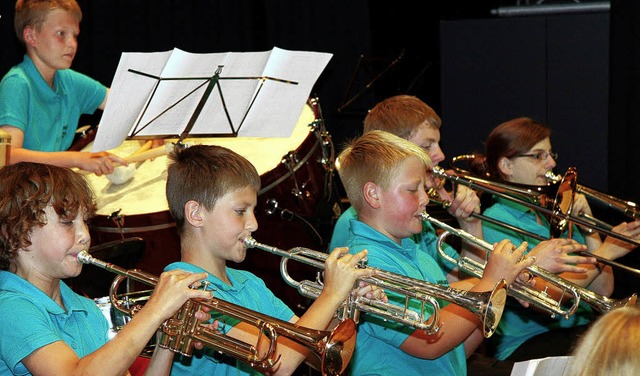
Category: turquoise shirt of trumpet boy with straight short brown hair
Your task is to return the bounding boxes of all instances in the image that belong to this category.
[165,262,294,375]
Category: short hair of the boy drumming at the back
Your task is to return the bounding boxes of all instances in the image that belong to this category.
[13,0,82,43]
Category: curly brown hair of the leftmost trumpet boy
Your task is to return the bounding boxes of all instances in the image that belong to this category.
[0,162,96,270]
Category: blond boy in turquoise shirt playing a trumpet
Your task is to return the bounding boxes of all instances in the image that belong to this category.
[336,131,535,376]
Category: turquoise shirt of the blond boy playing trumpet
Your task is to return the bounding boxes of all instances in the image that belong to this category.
[345,219,467,376]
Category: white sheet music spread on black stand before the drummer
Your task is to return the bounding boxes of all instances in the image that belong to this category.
[92,47,332,151]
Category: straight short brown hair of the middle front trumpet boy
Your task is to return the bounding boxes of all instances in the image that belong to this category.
[166,145,260,234]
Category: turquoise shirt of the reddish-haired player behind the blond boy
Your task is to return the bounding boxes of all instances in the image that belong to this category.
[329,206,460,274]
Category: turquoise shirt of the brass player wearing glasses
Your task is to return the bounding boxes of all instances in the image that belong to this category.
[482,197,595,360]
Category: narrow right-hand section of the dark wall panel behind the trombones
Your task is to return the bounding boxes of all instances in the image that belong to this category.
[546,14,609,191]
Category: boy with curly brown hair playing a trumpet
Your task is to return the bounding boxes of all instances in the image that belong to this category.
[0,162,211,376]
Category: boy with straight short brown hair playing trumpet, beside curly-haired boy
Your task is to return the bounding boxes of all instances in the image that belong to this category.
[160,145,386,375]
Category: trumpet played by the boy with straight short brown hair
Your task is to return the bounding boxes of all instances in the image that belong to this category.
[244,237,507,338]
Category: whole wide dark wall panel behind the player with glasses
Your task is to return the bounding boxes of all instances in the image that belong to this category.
[441,13,609,190]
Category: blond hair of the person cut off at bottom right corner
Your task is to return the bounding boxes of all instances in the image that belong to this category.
[569,306,640,376]
